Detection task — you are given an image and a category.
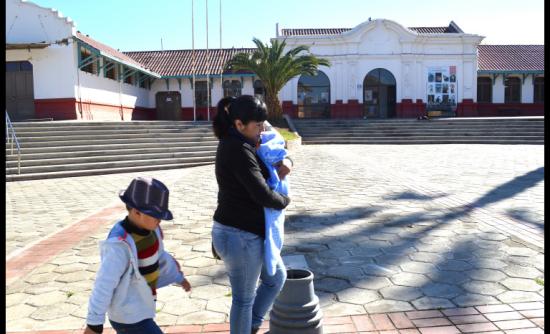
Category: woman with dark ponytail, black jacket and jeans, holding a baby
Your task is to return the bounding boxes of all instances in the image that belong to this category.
[212,95,291,334]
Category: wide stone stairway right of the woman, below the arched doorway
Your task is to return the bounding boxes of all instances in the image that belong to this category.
[292,116,544,145]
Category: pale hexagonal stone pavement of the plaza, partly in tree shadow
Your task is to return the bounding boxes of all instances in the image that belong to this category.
[6,145,544,332]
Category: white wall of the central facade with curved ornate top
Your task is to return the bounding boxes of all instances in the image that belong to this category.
[279,19,483,103]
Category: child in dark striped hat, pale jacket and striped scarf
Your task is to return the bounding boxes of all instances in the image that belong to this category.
[84,177,191,334]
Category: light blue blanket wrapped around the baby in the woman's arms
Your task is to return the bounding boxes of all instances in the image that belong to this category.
[257,131,289,276]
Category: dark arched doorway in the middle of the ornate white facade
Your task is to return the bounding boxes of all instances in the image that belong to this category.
[363,68,396,118]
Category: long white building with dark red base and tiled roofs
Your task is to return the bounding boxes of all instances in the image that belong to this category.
[6,0,544,120]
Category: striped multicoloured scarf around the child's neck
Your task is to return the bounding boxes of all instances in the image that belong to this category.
[123,219,160,300]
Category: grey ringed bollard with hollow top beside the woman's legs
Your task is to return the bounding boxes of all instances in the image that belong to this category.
[269,269,323,334]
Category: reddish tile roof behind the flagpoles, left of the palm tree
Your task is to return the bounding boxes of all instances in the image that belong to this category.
[125,48,256,76]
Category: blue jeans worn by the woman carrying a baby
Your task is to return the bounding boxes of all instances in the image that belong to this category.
[212,222,286,334]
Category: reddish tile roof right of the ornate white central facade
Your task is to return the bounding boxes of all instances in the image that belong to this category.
[477,44,544,71]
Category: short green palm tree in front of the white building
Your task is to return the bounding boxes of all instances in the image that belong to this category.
[226,38,330,119]
